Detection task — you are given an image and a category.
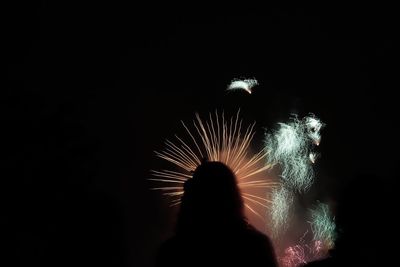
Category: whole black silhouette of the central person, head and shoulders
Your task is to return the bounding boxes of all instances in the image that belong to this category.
[157,162,277,267]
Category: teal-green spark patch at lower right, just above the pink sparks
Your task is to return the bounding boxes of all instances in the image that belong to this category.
[309,203,336,251]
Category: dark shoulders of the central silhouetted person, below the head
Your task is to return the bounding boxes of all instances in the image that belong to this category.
[157,226,277,266]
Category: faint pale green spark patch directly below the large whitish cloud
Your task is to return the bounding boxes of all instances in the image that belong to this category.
[269,186,293,237]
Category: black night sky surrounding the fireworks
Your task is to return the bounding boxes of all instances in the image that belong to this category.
[0,1,399,266]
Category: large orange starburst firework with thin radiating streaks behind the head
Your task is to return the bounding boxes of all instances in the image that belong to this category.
[150,112,279,217]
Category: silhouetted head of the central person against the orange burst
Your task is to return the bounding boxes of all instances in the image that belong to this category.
[177,161,246,232]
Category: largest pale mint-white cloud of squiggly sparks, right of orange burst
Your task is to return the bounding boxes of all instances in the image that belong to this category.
[264,116,323,192]
